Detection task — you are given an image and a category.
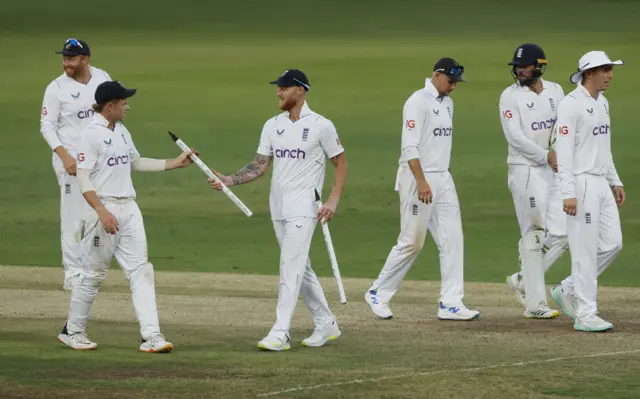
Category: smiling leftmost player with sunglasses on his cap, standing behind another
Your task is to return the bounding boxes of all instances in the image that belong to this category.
[40,39,111,290]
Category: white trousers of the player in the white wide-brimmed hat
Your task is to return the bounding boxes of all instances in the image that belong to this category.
[562,174,622,318]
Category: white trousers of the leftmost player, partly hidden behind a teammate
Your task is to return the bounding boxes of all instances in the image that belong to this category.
[52,153,91,278]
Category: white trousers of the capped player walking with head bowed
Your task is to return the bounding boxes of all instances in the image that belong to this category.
[369,167,464,307]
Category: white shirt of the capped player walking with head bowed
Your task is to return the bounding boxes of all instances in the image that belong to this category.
[399,78,453,172]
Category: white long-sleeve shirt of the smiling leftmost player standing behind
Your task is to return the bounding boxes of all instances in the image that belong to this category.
[40,66,111,157]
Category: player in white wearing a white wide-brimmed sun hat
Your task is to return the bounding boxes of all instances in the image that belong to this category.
[551,51,625,332]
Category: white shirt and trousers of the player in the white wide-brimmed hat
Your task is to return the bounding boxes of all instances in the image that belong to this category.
[556,84,622,318]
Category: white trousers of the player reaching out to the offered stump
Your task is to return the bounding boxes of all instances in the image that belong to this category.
[67,199,160,339]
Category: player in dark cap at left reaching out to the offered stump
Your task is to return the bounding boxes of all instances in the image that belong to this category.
[58,81,198,352]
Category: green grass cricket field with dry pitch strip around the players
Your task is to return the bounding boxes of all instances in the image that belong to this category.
[0,0,640,398]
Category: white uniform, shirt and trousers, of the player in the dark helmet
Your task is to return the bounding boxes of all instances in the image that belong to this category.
[499,79,566,311]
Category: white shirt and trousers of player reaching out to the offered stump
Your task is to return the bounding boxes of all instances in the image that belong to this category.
[67,114,160,339]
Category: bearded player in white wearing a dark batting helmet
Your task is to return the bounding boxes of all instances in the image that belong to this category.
[499,43,568,319]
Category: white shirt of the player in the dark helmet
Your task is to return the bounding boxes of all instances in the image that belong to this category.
[499,79,564,166]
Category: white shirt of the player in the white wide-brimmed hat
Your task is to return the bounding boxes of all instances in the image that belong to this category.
[556,85,622,199]
